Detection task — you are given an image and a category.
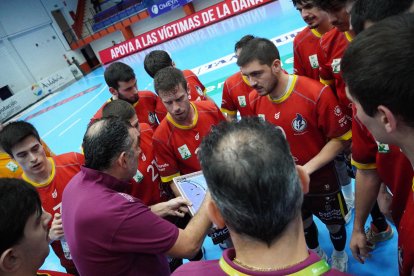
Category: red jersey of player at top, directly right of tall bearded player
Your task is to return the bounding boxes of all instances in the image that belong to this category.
[293,27,322,81]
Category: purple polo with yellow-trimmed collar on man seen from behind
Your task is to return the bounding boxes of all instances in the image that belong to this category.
[173,248,348,276]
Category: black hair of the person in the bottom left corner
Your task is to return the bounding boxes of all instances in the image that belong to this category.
[0,178,42,255]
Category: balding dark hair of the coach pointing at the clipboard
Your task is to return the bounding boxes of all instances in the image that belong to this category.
[82,117,133,171]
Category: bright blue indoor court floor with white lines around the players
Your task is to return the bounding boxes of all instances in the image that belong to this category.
[14,0,398,275]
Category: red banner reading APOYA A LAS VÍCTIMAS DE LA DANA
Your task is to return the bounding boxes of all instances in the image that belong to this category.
[99,0,274,64]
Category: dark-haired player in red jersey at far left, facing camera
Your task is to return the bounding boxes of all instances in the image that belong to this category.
[0,121,84,274]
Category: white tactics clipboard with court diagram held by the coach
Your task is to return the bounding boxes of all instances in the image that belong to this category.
[173,171,208,216]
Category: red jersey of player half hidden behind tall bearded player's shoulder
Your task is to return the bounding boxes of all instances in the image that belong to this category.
[221,72,254,117]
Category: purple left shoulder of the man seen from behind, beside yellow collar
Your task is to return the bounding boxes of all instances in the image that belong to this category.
[172,260,226,276]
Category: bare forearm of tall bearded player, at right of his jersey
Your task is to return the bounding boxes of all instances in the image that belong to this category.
[303,134,352,175]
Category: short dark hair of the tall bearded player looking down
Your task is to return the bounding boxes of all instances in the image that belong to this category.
[237,38,280,66]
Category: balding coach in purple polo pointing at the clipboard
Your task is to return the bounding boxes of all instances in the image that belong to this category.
[62,118,210,276]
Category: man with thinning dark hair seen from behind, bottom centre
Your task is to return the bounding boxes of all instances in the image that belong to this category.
[173,118,343,275]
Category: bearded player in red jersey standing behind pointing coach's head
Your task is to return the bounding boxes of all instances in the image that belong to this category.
[91,62,158,129]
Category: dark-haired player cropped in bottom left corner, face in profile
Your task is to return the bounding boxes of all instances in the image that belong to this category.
[0,178,68,276]
